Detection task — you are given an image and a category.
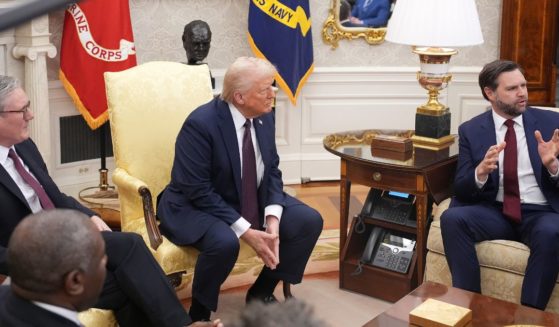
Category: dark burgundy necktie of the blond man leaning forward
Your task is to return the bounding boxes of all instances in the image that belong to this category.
[241,119,260,229]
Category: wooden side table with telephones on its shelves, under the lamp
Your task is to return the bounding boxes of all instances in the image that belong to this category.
[324,130,458,301]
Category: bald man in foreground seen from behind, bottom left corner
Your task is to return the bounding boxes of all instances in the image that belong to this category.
[0,209,107,327]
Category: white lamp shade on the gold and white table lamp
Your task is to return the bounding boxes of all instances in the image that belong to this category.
[385,0,483,47]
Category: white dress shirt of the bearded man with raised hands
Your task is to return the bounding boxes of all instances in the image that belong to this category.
[474,110,559,205]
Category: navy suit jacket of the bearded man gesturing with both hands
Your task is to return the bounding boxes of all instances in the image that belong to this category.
[452,107,559,212]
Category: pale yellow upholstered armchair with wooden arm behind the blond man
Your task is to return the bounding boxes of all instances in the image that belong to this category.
[105,62,213,287]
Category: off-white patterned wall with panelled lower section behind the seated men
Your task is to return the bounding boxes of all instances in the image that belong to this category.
[0,0,501,194]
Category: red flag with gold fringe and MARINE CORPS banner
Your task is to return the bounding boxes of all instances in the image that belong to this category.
[59,0,136,129]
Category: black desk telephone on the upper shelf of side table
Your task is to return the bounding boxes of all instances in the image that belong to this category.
[361,188,417,227]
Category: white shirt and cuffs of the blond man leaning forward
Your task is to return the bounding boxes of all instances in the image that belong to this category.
[229,103,283,237]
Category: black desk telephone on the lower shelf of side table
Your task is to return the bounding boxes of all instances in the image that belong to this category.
[361,226,415,274]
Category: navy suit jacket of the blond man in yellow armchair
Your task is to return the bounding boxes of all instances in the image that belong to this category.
[157,98,285,245]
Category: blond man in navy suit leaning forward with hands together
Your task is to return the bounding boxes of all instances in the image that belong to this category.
[157,57,322,321]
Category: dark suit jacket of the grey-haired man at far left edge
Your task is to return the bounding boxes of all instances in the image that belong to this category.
[0,139,95,275]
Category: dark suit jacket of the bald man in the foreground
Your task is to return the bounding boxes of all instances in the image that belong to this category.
[0,286,78,327]
